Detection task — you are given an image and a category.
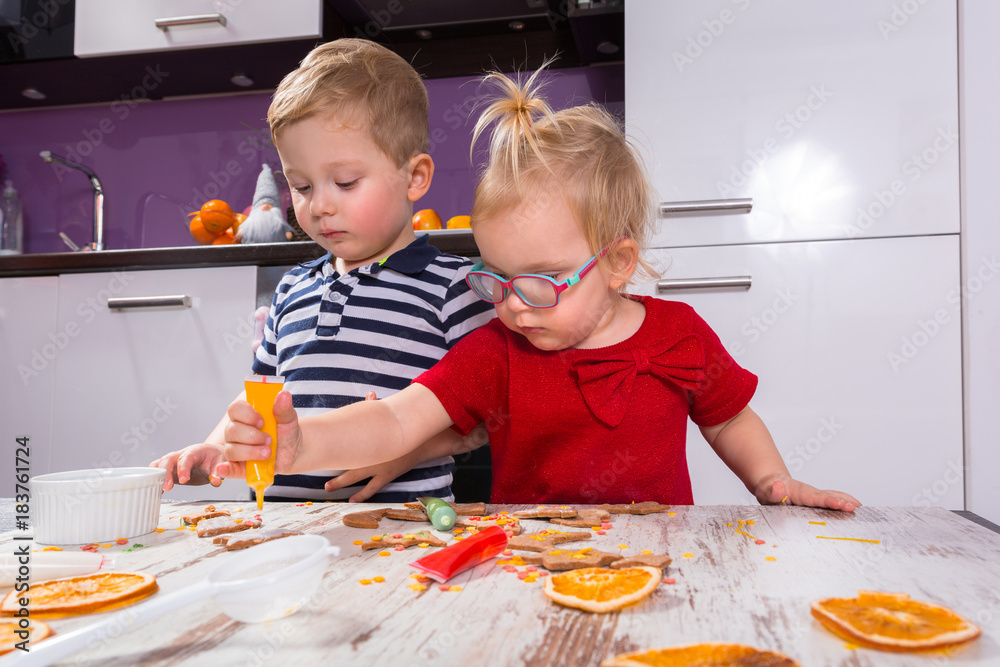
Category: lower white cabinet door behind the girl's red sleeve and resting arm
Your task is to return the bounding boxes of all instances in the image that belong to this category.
[635,235,964,509]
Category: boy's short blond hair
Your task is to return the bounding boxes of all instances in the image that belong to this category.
[267,38,429,167]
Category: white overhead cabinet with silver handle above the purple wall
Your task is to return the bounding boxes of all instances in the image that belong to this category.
[73,0,323,58]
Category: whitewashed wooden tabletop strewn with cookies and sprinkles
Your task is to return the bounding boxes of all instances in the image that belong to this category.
[0,503,1000,667]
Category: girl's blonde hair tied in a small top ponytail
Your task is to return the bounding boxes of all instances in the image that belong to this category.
[472,62,656,276]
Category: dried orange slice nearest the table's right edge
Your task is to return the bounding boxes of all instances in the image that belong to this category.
[812,591,980,651]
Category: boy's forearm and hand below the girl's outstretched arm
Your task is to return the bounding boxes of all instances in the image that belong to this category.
[326,425,489,503]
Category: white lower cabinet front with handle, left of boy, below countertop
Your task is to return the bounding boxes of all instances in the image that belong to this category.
[52,266,257,500]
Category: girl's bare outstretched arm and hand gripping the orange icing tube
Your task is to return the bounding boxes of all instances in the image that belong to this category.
[217,384,453,477]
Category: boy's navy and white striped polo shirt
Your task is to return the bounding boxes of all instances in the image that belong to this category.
[253,235,494,503]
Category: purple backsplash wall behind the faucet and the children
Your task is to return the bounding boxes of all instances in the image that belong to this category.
[0,66,624,253]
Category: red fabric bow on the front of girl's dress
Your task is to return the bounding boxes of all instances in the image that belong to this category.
[572,334,705,427]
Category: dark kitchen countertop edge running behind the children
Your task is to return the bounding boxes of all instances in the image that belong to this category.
[0,230,478,278]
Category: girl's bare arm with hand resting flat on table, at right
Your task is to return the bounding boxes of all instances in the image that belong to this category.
[701,406,861,512]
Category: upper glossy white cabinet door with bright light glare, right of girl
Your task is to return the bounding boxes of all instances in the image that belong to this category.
[625,0,959,246]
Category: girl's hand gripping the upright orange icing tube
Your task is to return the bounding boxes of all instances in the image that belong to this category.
[221,391,302,477]
